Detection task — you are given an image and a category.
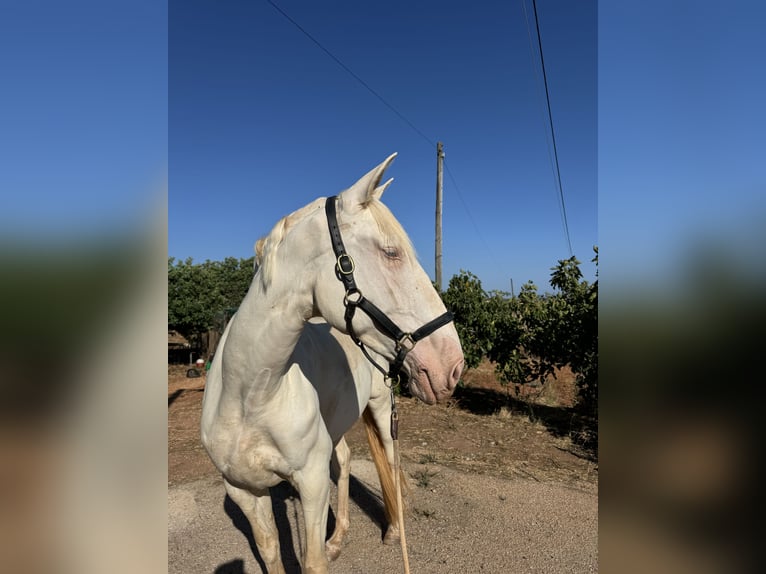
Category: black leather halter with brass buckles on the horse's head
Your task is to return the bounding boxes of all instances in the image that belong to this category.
[325,196,453,382]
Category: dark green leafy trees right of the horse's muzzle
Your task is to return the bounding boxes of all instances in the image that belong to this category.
[442,248,598,416]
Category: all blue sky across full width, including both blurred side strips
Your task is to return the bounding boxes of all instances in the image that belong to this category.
[0,0,766,296]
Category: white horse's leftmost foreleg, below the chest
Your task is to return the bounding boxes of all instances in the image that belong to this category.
[223,479,285,574]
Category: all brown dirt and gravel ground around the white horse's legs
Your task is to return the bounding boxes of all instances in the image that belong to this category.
[168,363,598,574]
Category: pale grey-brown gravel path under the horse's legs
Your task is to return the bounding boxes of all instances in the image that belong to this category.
[168,459,598,574]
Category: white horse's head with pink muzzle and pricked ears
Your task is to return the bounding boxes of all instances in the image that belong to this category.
[315,154,464,404]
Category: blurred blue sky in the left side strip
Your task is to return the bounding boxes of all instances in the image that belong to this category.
[0,0,167,245]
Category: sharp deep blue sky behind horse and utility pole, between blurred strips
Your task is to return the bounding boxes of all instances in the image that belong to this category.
[168,0,598,291]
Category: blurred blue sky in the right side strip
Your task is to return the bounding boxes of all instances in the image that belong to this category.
[598,0,766,295]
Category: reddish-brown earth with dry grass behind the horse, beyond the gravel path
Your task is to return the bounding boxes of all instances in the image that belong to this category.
[168,364,598,490]
